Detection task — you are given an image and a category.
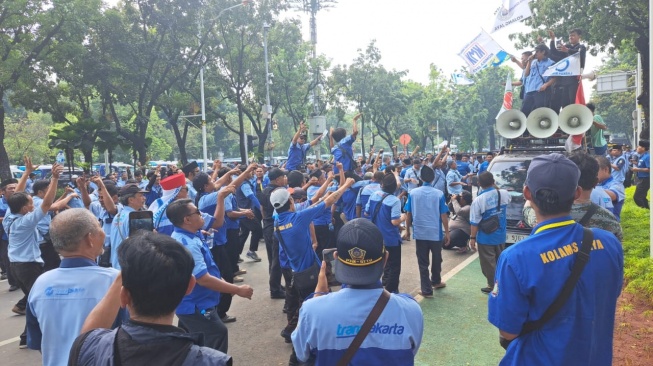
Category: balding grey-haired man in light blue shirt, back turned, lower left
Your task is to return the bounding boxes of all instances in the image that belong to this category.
[26,208,121,366]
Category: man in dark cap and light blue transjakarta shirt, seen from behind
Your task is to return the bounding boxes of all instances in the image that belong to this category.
[292,219,424,365]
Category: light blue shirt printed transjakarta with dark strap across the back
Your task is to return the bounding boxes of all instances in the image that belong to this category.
[292,288,424,366]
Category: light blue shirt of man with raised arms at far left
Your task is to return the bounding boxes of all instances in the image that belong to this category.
[2,208,47,263]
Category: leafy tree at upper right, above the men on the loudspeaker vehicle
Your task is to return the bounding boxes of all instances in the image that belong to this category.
[511,0,650,139]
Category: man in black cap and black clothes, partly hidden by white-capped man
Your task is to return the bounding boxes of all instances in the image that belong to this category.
[261,168,288,299]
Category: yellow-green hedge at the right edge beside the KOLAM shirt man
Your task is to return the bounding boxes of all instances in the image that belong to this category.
[621,187,653,304]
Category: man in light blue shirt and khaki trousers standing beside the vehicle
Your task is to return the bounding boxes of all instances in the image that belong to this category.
[469,172,510,294]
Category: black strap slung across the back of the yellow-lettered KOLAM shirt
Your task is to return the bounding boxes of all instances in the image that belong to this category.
[499,226,594,349]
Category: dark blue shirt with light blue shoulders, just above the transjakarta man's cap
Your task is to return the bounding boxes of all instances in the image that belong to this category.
[365,191,401,247]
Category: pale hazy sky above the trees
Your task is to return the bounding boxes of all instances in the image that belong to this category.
[287,0,600,90]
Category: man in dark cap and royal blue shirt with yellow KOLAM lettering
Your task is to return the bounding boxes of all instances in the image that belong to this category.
[488,154,623,365]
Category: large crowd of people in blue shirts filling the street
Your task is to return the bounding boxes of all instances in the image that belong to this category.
[0,100,649,365]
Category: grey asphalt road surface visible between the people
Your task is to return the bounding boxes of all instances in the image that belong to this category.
[0,237,472,366]
